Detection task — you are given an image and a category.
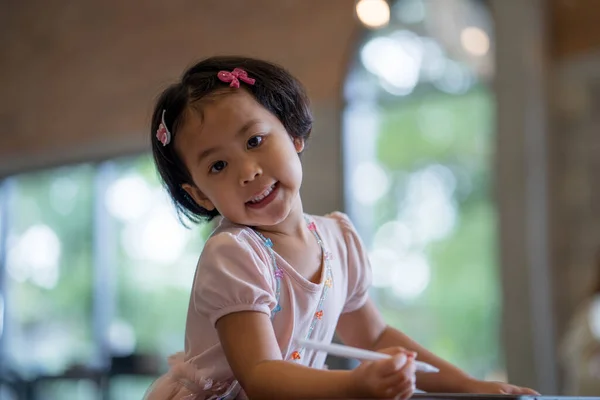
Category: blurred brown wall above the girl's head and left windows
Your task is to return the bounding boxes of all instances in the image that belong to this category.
[0,0,360,177]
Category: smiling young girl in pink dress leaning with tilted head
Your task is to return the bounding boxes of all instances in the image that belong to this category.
[147,57,535,400]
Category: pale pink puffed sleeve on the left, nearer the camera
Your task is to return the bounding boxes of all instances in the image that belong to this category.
[192,232,277,326]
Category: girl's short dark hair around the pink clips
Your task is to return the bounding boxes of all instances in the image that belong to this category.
[150,56,313,223]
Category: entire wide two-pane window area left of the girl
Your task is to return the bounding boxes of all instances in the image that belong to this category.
[0,155,210,400]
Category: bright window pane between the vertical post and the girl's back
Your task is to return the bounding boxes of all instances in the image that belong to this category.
[105,157,211,359]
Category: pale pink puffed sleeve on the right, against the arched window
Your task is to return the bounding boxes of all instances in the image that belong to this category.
[329,212,371,313]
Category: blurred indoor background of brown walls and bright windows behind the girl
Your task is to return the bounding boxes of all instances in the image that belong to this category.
[0,0,600,400]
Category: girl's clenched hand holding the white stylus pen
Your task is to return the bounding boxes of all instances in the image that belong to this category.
[352,347,416,400]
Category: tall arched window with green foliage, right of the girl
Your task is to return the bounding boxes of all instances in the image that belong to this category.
[344,0,503,379]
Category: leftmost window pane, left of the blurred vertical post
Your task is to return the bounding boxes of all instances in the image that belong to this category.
[4,165,95,377]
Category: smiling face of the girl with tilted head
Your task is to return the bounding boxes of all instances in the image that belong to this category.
[175,89,304,227]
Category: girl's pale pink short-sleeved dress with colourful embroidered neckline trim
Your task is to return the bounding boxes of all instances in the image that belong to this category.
[146,212,371,400]
